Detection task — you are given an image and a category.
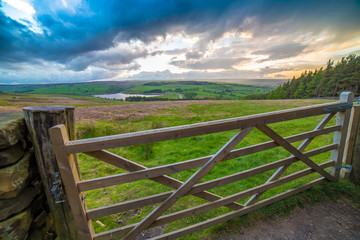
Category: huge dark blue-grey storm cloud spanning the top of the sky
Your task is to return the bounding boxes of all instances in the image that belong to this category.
[0,0,360,82]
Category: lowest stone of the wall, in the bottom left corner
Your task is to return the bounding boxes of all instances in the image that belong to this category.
[0,209,32,240]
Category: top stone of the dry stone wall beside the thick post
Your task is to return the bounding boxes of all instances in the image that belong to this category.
[0,113,27,149]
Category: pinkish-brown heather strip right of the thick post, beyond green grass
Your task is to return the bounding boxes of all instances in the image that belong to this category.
[75,101,219,121]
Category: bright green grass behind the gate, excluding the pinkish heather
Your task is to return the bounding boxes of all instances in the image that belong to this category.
[71,100,360,239]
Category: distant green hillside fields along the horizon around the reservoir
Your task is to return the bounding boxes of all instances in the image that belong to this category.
[0,81,275,100]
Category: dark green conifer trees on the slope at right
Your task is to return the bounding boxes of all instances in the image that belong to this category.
[266,54,360,99]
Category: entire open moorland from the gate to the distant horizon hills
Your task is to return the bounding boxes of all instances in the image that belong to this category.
[0,75,360,239]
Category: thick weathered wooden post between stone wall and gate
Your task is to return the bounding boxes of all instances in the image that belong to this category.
[23,106,79,240]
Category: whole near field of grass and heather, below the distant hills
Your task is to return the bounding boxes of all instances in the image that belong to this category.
[0,93,360,239]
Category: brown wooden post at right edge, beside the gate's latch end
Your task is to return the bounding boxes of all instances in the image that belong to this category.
[346,105,360,184]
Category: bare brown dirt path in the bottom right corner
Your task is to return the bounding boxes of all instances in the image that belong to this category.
[214,201,360,240]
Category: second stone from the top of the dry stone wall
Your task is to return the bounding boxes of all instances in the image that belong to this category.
[0,140,26,167]
